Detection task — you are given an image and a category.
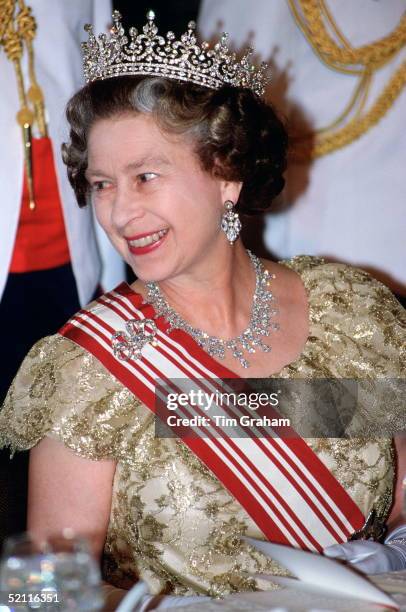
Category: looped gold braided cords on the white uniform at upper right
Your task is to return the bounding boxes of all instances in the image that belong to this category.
[288,0,406,162]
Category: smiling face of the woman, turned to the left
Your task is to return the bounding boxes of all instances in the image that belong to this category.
[86,114,239,281]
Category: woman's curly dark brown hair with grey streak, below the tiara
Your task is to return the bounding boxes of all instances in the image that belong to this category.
[62,76,288,215]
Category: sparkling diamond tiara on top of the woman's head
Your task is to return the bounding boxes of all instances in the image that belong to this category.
[82,11,269,96]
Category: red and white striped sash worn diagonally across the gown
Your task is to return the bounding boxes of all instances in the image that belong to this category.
[59,283,364,551]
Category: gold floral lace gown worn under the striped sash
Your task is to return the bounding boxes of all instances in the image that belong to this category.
[0,257,406,595]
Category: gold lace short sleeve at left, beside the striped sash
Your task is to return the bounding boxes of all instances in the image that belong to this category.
[0,335,148,460]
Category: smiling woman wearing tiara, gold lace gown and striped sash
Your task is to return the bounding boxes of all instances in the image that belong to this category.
[0,8,405,608]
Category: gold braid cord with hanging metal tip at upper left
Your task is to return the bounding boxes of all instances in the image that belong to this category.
[0,0,47,210]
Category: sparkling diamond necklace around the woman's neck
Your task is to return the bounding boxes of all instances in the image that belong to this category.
[146,251,279,368]
